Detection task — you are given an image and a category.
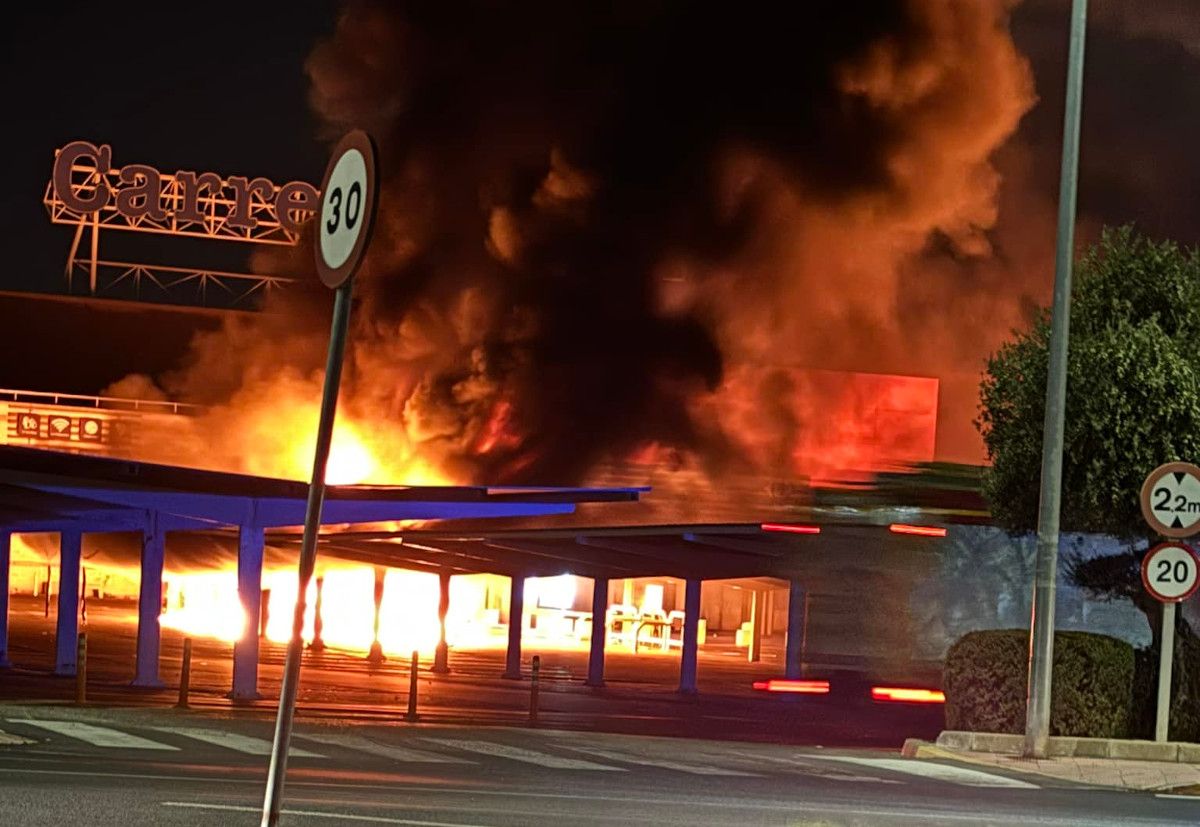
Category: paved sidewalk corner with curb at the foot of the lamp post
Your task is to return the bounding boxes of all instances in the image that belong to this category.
[904,732,1200,795]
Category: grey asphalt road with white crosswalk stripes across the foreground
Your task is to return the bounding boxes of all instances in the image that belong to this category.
[0,706,1200,827]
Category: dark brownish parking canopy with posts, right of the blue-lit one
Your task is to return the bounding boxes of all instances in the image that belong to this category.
[258,520,944,693]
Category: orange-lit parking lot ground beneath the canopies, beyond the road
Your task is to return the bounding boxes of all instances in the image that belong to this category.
[0,598,944,749]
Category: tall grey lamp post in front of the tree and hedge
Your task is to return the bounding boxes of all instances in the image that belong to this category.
[1025,0,1087,757]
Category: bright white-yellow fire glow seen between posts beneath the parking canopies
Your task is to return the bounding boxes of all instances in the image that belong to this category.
[11,535,768,655]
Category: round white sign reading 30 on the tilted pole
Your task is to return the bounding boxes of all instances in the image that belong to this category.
[316,130,378,288]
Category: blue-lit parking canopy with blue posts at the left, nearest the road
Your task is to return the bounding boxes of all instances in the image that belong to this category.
[0,445,644,699]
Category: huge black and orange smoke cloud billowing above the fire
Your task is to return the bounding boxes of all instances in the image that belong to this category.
[164,0,1032,483]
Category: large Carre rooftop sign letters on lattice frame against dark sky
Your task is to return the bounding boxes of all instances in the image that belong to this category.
[46,140,319,245]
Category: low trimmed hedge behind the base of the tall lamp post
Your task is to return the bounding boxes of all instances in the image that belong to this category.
[943,629,1134,738]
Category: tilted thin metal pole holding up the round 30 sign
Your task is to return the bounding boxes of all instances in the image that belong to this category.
[263,278,354,827]
